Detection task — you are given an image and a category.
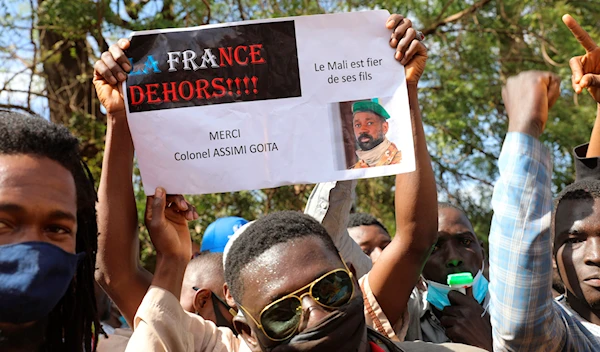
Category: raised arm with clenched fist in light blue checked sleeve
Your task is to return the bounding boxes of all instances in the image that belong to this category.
[489,71,566,351]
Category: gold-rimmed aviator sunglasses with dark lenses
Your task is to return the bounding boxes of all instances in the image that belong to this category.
[238,259,354,341]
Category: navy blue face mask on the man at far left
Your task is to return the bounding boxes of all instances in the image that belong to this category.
[0,242,84,324]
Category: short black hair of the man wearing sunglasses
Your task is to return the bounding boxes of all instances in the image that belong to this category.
[225,211,337,303]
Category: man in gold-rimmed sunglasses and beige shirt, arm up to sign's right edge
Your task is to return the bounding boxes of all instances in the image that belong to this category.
[119,15,481,352]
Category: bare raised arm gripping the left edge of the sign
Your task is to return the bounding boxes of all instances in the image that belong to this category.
[94,39,152,325]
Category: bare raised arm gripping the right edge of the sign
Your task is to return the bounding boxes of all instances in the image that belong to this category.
[369,15,437,322]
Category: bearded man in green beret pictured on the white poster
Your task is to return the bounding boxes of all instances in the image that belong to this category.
[350,100,402,169]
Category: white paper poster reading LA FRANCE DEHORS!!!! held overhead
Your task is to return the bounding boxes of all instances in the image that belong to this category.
[123,11,415,194]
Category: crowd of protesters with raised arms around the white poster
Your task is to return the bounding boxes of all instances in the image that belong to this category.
[0,11,600,352]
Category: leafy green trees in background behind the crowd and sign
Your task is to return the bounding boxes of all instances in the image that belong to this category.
[0,0,600,262]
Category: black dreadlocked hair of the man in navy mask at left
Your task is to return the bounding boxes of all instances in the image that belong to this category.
[0,111,101,352]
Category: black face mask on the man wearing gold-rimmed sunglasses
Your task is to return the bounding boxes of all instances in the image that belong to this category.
[266,295,367,352]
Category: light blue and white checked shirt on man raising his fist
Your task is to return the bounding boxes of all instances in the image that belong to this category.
[489,133,600,351]
